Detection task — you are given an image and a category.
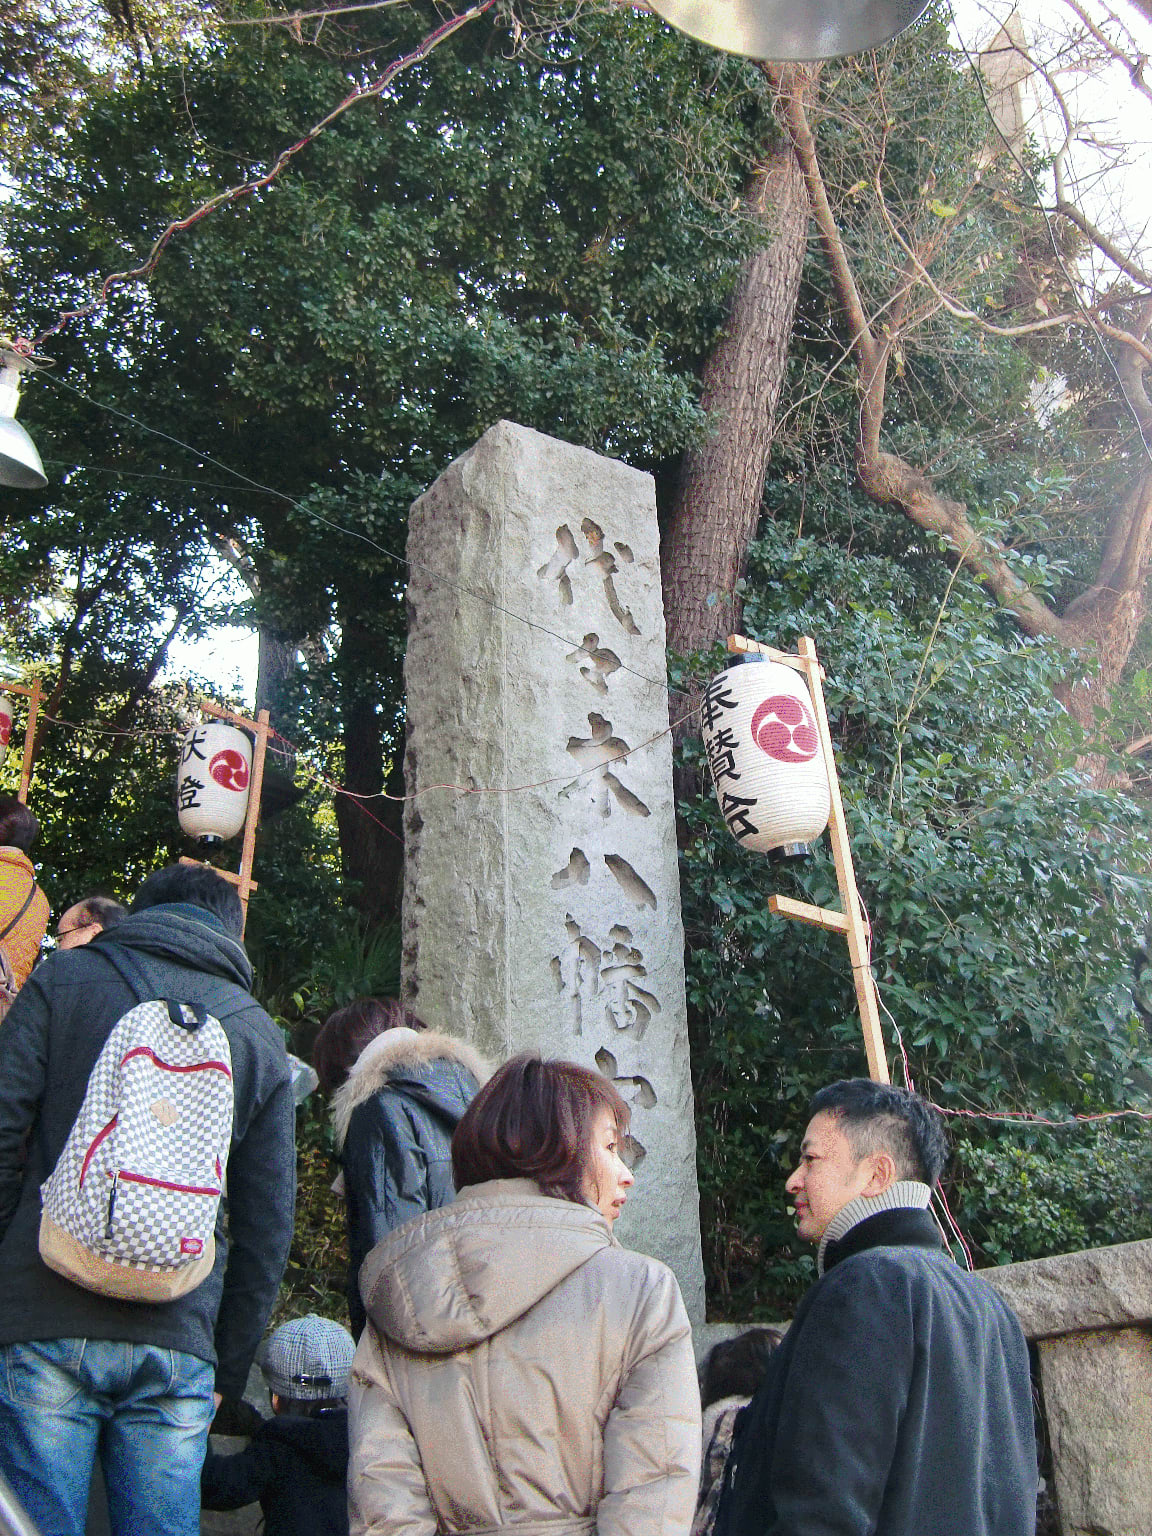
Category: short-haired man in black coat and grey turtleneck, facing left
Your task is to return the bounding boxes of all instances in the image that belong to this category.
[716,1078,1037,1536]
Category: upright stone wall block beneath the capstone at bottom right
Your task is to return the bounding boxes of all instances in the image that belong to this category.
[1040,1327,1152,1536]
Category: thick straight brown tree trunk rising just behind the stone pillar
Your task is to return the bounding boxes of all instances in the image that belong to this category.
[664,75,811,654]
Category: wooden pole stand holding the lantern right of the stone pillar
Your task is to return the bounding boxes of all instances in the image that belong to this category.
[728,634,891,1083]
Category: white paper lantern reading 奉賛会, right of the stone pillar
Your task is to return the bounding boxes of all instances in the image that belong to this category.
[700,660,831,854]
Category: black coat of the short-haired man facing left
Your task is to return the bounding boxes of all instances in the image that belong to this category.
[716,1209,1037,1536]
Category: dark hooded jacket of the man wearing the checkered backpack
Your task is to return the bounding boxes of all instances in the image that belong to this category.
[0,903,296,1396]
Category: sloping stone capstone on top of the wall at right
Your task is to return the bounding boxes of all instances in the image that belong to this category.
[980,1240,1152,1339]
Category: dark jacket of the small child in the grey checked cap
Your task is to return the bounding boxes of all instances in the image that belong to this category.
[200,1409,349,1536]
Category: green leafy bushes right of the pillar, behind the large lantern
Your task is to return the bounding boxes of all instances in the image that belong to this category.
[680,518,1152,1316]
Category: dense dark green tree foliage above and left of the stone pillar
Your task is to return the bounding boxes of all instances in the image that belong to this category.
[0,5,768,920]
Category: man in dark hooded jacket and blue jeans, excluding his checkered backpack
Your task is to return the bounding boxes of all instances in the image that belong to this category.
[0,865,295,1536]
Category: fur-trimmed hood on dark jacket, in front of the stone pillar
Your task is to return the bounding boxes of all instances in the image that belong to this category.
[332,1029,492,1150]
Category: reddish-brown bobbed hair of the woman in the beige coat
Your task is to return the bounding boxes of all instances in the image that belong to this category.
[452,1052,628,1204]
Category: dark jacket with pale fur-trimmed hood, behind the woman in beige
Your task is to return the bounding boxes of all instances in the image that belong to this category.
[332,1029,488,1338]
